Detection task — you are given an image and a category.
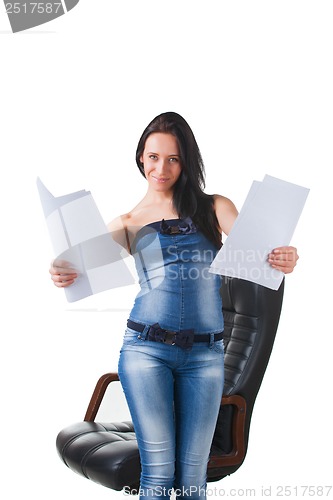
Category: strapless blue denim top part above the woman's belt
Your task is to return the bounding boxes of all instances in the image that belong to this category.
[129,218,223,334]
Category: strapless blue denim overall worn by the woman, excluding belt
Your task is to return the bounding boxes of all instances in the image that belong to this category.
[119,219,224,500]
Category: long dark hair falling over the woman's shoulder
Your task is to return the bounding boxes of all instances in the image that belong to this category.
[136,112,222,248]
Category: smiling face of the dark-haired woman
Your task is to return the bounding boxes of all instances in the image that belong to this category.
[140,132,182,192]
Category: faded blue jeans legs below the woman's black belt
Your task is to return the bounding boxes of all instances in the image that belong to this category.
[118,328,224,500]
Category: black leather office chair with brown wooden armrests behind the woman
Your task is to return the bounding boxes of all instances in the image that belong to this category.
[56,278,284,493]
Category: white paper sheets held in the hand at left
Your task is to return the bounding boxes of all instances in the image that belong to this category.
[37,178,136,302]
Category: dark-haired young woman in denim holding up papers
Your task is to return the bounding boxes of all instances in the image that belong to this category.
[50,112,298,500]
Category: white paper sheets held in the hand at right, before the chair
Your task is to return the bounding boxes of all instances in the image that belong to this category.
[210,175,309,290]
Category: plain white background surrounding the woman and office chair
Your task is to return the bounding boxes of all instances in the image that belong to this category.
[0,0,333,500]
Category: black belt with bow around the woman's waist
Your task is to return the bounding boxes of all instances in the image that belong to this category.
[127,319,223,348]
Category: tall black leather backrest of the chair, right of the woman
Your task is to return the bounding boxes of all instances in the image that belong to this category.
[208,278,284,481]
